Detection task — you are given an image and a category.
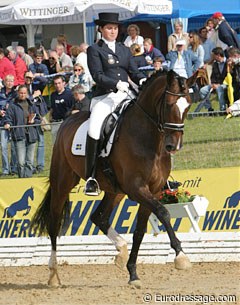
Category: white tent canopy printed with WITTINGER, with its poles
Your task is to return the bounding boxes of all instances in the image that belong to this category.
[0,0,172,45]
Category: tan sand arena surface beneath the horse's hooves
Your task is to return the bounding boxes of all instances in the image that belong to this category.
[0,262,240,305]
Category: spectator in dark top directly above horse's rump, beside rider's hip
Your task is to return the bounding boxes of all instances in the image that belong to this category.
[71,85,91,114]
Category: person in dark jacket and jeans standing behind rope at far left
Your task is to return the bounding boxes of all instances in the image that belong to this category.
[4,85,40,178]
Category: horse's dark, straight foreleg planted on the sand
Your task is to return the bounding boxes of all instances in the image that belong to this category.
[127,205,151,288]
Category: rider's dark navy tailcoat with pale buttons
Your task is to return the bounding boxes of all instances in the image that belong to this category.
[87,39,145,96]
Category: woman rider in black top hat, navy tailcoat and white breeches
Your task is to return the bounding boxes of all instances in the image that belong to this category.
[84,13,146,195]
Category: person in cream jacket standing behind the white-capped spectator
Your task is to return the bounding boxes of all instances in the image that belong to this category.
[168,20,189,52]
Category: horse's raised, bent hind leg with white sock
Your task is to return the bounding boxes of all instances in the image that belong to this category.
[91,193,128,269]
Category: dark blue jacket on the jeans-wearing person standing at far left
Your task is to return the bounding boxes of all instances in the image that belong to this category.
[4,98,41,143]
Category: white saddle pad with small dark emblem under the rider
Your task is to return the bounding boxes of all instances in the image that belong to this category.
[72,119,116,157]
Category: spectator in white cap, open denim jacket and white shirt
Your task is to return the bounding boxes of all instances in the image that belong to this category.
[166,39,200,78]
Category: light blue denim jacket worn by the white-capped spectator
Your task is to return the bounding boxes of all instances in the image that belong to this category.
[166,50,201,78]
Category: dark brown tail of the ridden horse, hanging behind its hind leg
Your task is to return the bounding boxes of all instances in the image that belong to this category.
[30,186,70,236]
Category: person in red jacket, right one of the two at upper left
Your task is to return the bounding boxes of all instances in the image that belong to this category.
[7,46,27,85]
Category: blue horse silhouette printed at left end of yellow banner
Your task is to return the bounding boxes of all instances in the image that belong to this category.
[3,187,34,218]
